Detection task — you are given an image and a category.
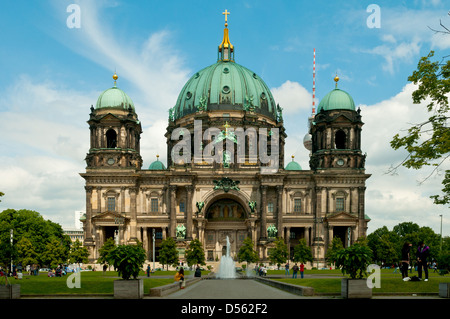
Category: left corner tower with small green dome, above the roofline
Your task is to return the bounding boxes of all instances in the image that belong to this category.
[86,74,142,169]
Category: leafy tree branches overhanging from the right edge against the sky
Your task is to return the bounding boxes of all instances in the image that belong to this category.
[391,50,450,204]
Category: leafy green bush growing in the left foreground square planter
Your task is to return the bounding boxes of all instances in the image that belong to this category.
[109,244,145,280]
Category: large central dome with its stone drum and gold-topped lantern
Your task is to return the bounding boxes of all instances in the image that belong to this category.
[165,16,286,170]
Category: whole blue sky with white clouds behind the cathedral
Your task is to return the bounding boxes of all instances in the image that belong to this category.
[0,0,450,235]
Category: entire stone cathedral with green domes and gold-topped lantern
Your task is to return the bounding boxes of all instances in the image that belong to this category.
[80,12,370,267]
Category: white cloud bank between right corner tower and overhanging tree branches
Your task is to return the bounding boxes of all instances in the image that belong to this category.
[360,84,450,232]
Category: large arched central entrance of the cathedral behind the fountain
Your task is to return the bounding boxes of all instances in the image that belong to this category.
[205,194,249,261]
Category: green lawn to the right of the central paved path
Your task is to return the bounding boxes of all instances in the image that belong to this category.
[268,269,450,294]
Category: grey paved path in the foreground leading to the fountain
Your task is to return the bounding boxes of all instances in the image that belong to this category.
[157,279,305,299]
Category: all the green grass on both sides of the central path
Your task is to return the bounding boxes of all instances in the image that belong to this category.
[6,269,450,295]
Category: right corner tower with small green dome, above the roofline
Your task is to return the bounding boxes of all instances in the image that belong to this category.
[310,76,366,172]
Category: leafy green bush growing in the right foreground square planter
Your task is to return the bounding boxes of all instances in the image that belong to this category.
[336,243,372,279]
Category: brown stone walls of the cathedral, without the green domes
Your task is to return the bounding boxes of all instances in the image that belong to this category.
[81,100,370,267]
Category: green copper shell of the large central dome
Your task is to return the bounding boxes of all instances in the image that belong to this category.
[174,60,276,119]
